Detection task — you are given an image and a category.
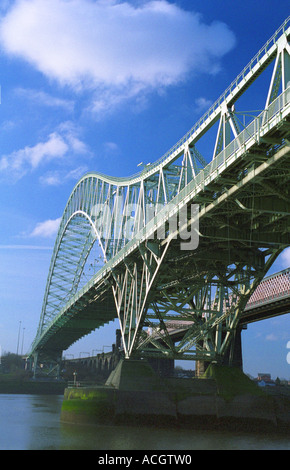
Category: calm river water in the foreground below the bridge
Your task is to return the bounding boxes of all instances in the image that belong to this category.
[0,395,290,451]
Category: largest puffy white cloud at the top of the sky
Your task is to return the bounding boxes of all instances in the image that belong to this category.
[0,0,235,113]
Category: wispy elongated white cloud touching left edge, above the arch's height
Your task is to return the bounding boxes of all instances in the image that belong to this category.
[0,122,89,180]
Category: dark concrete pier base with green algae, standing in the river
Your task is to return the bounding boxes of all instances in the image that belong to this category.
[61,352,288,430]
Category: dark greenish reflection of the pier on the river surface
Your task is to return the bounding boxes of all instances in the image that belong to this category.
[61,425,290,451]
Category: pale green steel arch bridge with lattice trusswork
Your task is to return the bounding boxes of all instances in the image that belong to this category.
[30,17,290,376]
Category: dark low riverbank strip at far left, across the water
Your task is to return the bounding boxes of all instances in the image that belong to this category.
[0,374,67,395]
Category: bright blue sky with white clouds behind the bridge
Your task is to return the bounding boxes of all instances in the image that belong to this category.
[0,0,290,378]
